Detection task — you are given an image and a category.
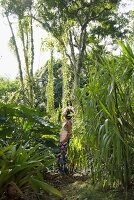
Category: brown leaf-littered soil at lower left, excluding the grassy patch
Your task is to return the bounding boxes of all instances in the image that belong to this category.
[0,172,87,200]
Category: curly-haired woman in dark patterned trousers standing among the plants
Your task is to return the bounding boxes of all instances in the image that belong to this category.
[58,107,74,174]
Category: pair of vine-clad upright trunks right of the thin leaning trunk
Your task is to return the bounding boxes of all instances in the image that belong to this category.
[19,17,34,107]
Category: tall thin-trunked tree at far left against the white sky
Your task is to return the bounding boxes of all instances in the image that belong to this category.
[1,0,34,107]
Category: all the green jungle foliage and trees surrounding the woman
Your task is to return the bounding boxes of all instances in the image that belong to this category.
[0,0,134,196]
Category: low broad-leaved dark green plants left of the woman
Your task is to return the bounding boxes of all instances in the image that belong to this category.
[0,103,61,196]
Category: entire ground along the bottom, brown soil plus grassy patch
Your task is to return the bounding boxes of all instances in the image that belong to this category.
[0,173,134,200]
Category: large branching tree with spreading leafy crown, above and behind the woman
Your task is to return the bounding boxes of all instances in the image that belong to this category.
[37,0,124,92]
